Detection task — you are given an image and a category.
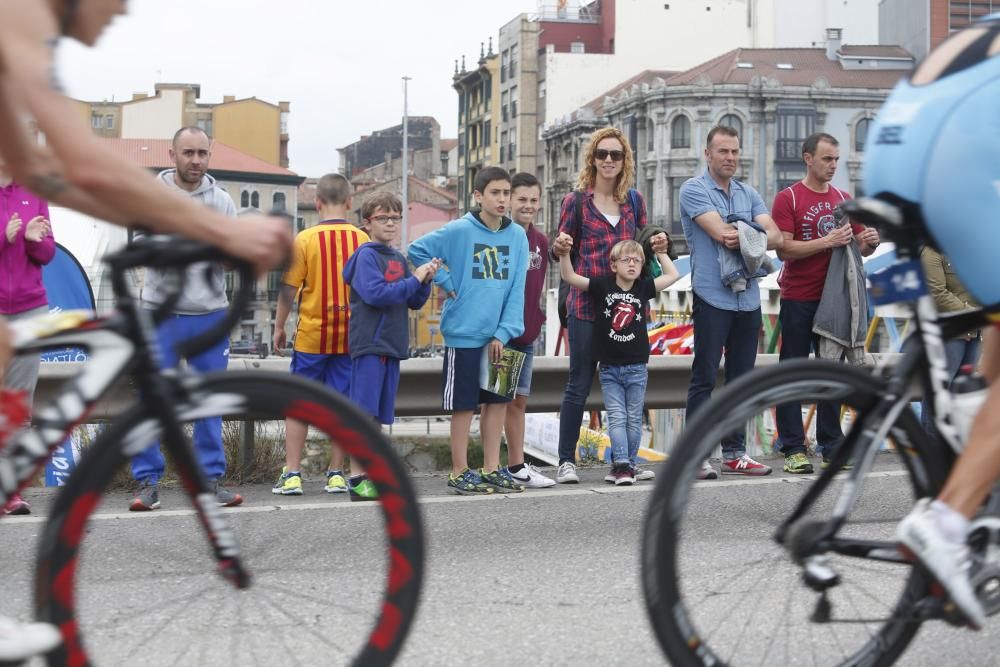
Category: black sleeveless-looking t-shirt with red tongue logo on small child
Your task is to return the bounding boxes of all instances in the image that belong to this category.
[588,275,656,366]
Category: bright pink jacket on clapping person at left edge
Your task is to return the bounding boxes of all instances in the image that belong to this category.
[0,183,56,315]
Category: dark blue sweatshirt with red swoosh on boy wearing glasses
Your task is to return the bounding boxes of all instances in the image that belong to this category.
[344,242,431,359]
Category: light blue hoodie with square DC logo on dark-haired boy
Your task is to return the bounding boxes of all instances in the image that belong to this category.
[410,213,528,348]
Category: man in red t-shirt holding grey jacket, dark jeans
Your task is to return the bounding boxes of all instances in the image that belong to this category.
[771,132,879,474]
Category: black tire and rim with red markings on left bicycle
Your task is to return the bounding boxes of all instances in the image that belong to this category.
[35,371,424,667]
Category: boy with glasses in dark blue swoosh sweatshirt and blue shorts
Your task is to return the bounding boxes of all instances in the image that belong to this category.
[344,192,441,500]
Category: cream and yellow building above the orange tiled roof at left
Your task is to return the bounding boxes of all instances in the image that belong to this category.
[74,83,290,168]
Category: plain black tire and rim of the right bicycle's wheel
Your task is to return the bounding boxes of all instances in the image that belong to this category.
[641,360,930,667]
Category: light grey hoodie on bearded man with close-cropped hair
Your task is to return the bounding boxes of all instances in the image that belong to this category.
[136,169,236,315]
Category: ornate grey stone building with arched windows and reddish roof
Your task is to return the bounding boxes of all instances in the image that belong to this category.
[545,43,914,251]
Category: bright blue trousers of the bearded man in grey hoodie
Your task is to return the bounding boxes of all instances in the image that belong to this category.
[132,310,229,484]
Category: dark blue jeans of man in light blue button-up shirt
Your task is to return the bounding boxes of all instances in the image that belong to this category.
[685,294,761,460]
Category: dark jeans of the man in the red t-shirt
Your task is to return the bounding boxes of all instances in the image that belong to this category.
[775,299,844,458]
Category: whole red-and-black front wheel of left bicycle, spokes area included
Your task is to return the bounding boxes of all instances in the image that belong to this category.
[36,372,424,667]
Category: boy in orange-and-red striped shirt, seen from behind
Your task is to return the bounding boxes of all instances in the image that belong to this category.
[271,174,377,500]
